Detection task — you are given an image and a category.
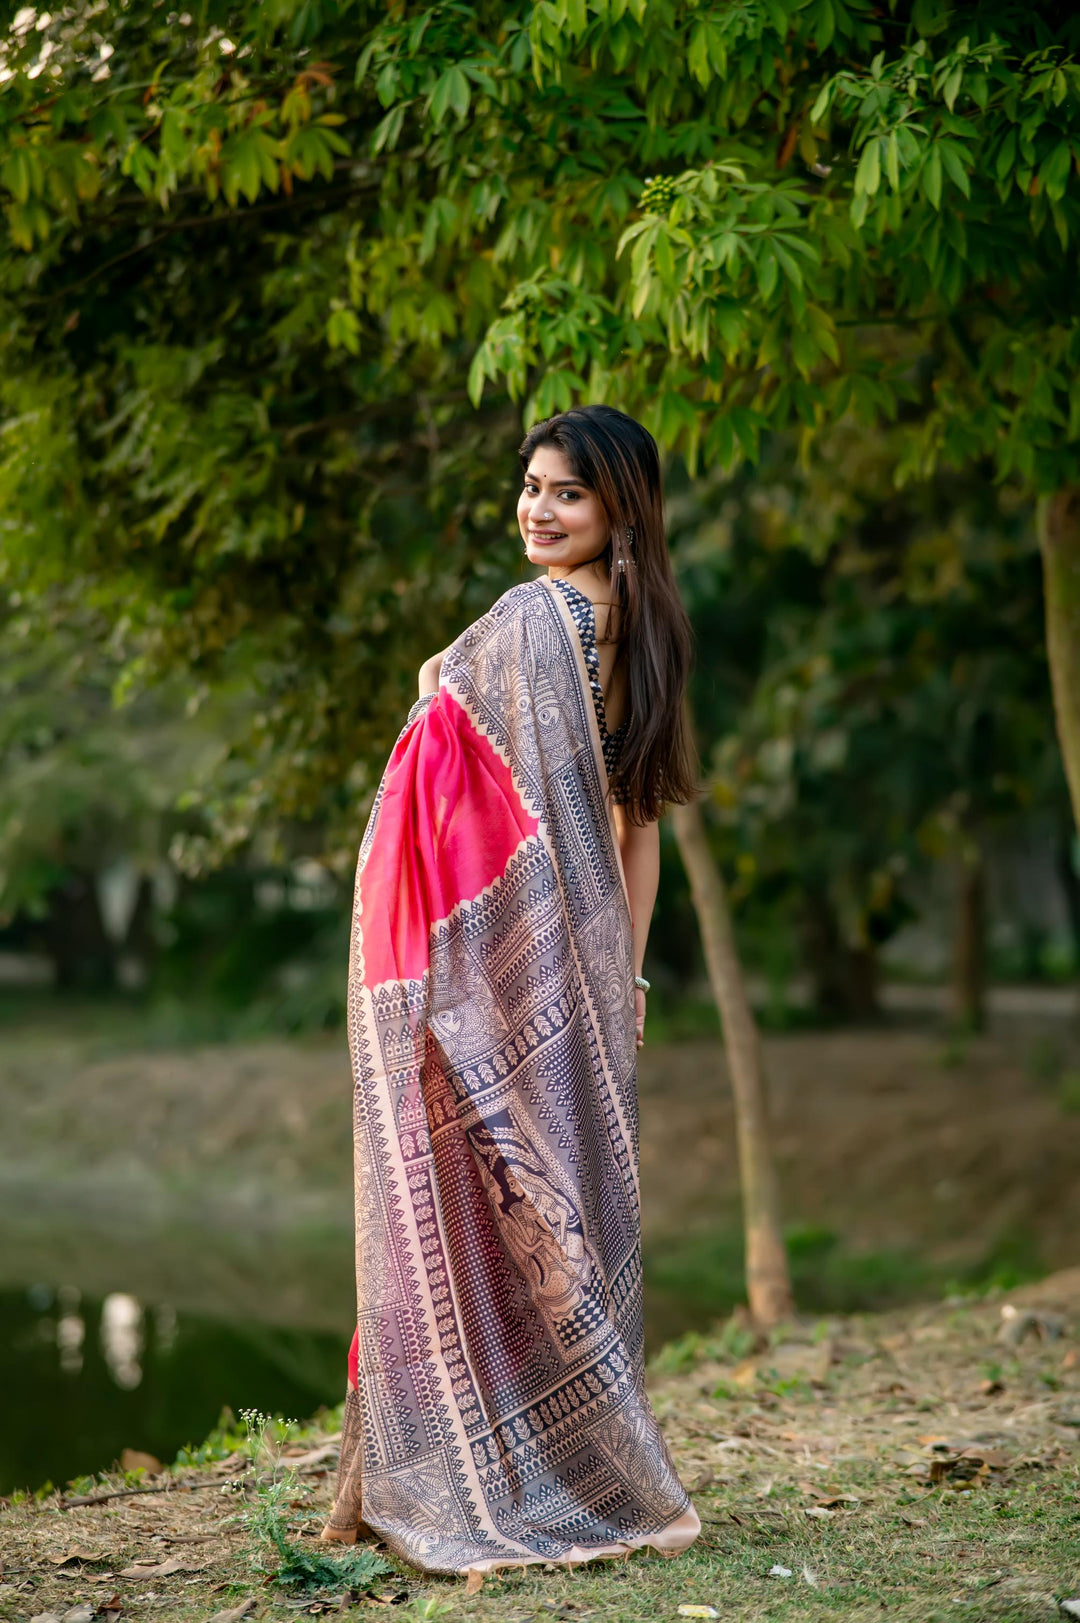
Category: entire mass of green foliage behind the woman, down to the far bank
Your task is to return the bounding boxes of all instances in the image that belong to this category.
[0,0,1080,1029]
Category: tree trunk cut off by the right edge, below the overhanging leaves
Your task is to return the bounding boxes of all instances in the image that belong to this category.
[1036,485,1080,828]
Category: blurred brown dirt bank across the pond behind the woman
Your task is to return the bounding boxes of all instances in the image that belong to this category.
[0,1022,1080,1328]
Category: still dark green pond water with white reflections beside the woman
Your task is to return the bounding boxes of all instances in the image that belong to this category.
[0,1216,715,1493]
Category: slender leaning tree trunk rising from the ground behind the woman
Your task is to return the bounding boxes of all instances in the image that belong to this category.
[671,802,794,1329]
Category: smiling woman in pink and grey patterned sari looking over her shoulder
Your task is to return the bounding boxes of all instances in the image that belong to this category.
[323,406,700,1573]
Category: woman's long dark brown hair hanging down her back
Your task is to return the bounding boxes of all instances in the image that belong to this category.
[518,406,697,823]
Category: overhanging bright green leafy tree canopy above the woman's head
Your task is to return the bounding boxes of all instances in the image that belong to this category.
[0,0,1080,837]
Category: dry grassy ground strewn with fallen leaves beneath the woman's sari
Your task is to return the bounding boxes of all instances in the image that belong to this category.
[0,1278,1080,1623]
